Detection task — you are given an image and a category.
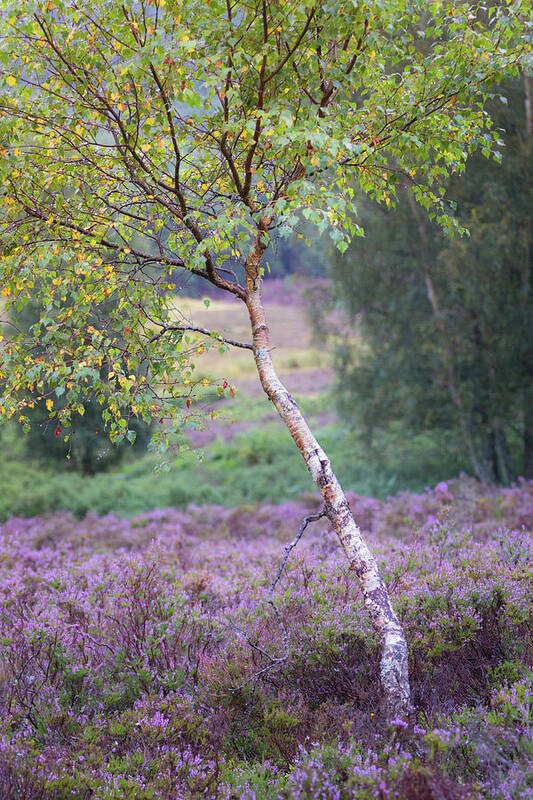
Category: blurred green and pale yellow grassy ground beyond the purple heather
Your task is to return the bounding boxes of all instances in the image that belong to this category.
[0,280,478,519]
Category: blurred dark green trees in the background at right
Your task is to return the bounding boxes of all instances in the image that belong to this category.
[333,75,533,484]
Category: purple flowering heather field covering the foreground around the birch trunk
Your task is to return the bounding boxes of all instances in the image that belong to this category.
[0,478,533,800]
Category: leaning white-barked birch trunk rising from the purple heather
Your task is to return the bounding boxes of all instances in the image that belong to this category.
[246,272,410,721]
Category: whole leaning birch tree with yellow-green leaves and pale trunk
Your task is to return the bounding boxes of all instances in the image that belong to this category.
[0,0,531,719]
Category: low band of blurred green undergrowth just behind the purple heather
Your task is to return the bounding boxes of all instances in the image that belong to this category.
[0,416,474,520]
